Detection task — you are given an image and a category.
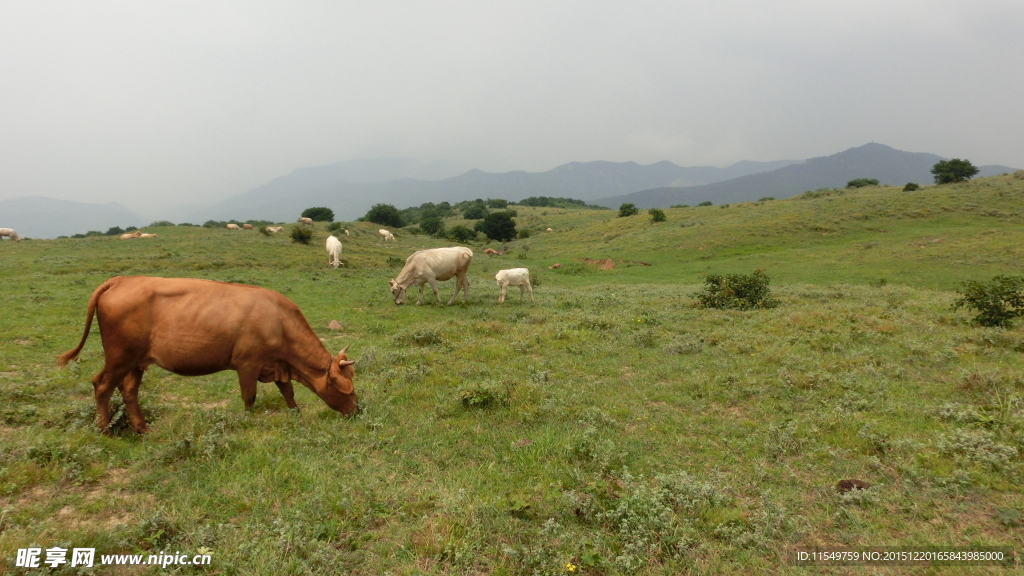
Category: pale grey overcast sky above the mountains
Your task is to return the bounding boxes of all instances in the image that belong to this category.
[0,0,1024,210]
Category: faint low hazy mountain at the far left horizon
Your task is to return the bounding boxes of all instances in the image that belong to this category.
[0,196,147,238]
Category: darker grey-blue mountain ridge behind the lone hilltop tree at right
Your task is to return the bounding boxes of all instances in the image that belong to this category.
[594,142,1015,208]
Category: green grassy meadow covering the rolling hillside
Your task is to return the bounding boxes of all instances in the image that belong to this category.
[0,176,1024,575]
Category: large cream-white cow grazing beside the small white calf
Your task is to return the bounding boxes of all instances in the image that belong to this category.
[388,246,473,305]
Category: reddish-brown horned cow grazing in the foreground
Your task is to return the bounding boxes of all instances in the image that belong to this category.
[57,276,356,434]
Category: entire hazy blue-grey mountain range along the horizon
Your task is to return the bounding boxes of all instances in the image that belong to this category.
[6,142,1015,238]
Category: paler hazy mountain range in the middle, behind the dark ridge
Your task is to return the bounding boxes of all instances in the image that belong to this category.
[193,159,799,221]
